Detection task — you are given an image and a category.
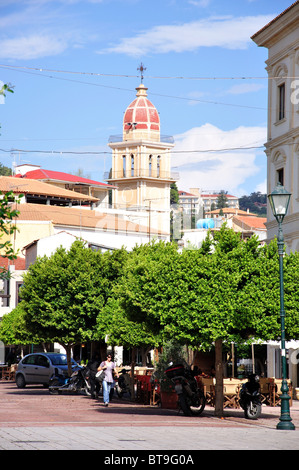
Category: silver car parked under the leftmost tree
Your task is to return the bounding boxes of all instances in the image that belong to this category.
[16,353,80,388]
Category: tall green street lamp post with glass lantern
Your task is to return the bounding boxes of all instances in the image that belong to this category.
[268,184,295,430]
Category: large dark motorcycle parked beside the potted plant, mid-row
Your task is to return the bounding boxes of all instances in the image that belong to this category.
[165,364,206,416]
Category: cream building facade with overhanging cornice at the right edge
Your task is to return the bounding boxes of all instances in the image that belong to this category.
[252,1,299,252]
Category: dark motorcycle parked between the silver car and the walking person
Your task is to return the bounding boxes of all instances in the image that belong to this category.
[49,367,90,396]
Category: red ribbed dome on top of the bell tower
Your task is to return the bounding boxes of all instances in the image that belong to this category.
[123,84,160,132]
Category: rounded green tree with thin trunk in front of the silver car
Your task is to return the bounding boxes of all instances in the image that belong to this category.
[20,241,109,372]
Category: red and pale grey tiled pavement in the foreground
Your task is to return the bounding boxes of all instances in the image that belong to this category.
[0,382,299,452]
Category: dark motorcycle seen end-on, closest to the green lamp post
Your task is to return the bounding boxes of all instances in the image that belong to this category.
[239,374,262,419]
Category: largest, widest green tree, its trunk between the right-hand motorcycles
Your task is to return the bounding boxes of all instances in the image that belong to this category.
[115,226,298,414]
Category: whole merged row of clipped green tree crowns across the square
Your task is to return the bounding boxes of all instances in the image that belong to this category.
[2,226,299,372]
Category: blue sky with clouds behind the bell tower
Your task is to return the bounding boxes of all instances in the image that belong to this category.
[0,0,292,196]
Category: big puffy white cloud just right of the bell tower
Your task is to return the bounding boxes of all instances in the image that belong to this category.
[171,124,267,196]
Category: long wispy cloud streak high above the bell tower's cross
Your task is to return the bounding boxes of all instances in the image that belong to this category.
[99,15,273,56]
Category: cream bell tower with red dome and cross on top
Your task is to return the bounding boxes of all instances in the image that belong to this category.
[107,79,175,239]
